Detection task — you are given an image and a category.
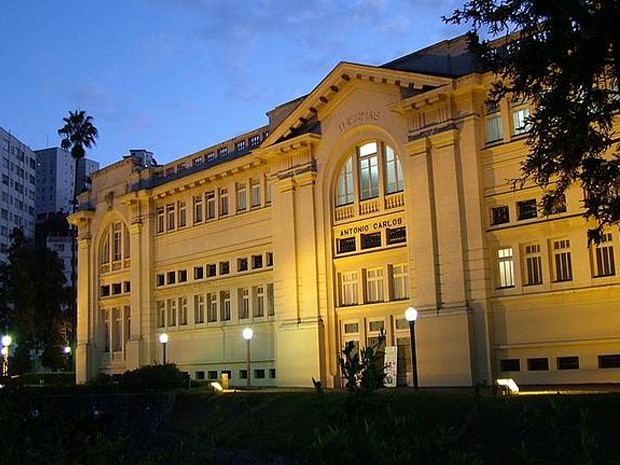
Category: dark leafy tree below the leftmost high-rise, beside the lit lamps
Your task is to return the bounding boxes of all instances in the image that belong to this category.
[0,229,69,373]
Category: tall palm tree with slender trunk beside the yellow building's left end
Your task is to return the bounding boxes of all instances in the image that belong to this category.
[58,110,99,364]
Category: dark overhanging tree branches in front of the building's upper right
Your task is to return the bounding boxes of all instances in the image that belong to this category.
[444,0,620,241]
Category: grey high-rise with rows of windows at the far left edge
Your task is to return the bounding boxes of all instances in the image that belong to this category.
[0,127,37,261]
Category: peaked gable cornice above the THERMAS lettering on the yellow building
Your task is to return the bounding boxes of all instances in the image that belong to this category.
[262,62,452,147]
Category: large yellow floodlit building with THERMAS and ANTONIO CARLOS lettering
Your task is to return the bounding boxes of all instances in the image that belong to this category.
[71,34,620,387]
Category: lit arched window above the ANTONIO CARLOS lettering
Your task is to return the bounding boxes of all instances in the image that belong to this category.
[336,140,404,207]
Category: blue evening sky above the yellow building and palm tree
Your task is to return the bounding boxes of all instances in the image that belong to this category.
[0,0,464,166]
